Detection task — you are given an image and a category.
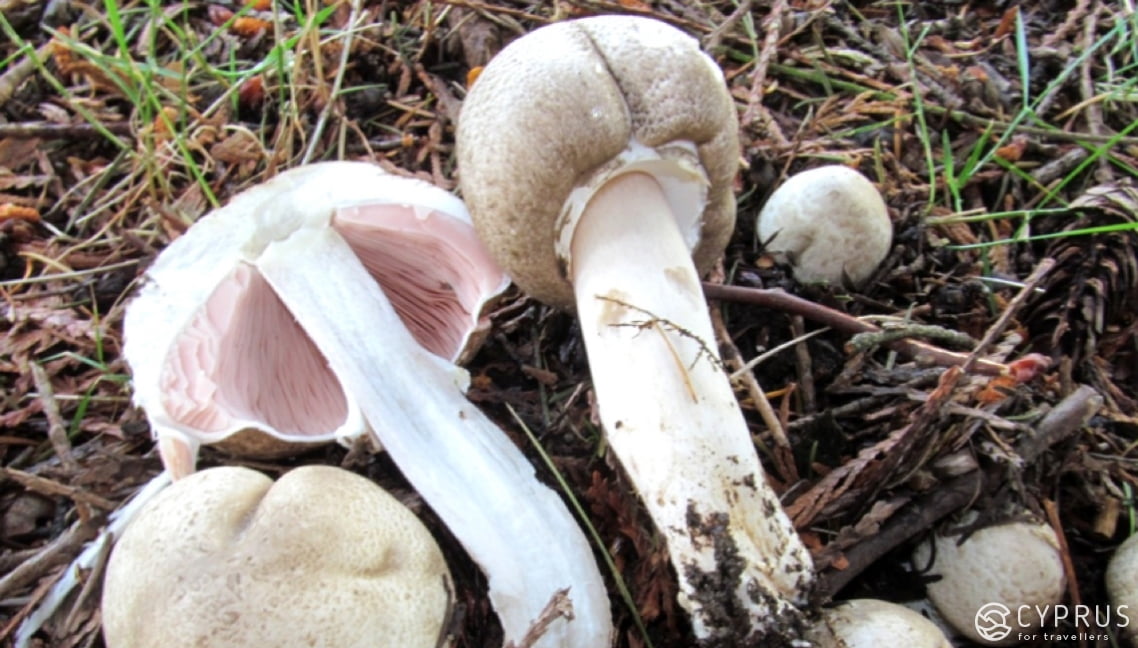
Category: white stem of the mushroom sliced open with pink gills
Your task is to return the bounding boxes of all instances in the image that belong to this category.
[256,228,611,648]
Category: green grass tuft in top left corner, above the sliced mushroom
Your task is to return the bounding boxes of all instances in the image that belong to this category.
[0,0,353,235]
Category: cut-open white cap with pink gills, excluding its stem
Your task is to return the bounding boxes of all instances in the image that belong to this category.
[123,162,509,469]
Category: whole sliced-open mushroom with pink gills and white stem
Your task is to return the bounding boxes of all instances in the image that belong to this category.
[118,162,611,647]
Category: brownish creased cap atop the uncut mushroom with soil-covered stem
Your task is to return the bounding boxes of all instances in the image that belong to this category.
[456,16,740,309]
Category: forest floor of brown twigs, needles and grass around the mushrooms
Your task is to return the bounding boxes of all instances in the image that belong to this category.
[0,0,1138,647]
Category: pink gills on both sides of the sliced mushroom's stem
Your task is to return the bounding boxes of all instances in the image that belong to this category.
[160,204,500,443]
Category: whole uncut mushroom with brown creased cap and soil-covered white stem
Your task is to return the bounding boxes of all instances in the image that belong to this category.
[456,16,814,645]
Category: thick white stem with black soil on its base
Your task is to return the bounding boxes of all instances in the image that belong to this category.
[571,173,814,643]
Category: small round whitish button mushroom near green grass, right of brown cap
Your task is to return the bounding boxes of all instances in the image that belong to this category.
[756,164,893,286]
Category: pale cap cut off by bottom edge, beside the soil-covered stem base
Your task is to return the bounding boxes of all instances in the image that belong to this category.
[811,599,951,648]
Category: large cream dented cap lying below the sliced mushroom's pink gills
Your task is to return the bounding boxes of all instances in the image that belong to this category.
[102,466,450,648]
